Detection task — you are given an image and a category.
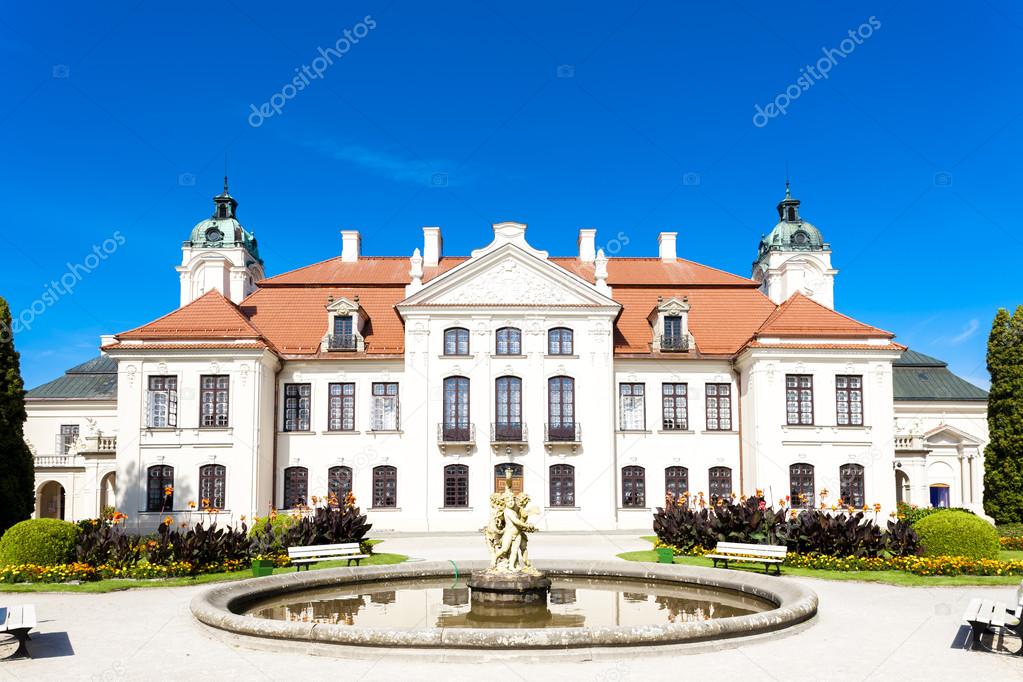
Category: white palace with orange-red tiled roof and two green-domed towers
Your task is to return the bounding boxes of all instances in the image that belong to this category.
[26,180,987,531]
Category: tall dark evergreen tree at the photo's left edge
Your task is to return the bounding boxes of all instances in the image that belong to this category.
[0,298,35,535]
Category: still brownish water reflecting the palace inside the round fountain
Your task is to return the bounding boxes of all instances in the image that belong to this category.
[248,578,774,630]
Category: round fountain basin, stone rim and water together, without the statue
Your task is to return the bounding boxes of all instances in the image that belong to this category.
[191,561,817,656]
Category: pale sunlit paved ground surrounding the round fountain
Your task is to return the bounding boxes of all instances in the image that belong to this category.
[0,533,1023,682]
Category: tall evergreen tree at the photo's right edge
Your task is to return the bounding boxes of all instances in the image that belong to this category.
[984,306,1023,524]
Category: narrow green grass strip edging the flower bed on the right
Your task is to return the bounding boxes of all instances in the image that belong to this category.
[618,536,1023,587]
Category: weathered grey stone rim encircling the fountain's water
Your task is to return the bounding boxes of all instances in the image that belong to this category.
[190,560,817,650]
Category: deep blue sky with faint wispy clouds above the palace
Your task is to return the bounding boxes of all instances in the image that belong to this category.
[0,0,1023,387]
